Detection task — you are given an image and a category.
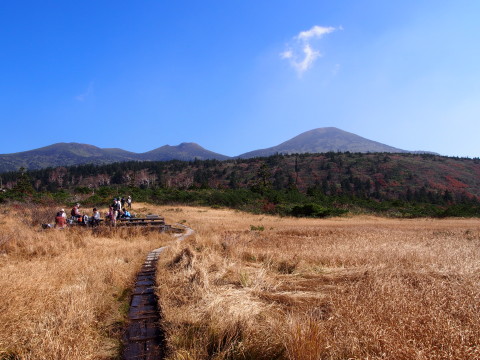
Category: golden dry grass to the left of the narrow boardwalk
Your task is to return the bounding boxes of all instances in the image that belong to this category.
[0,205,171,359]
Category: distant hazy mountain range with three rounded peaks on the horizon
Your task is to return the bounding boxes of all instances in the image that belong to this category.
[0,127,434,173]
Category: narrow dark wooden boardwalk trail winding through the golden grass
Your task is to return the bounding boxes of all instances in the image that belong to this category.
[123,224,194,360]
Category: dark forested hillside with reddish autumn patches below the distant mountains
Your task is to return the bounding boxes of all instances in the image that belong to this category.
[2,152,480,217]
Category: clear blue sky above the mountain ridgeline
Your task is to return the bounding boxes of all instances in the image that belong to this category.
[0,0,480,157]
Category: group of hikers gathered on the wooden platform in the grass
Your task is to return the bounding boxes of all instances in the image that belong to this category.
[55,196,132,229]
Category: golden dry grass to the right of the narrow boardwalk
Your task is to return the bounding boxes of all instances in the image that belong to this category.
[152,207,480,359]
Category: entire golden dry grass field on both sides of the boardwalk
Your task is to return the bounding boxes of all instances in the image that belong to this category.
[0,204,480,359]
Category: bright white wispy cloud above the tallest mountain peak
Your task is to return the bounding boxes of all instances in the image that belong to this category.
[280,25,343,76]
